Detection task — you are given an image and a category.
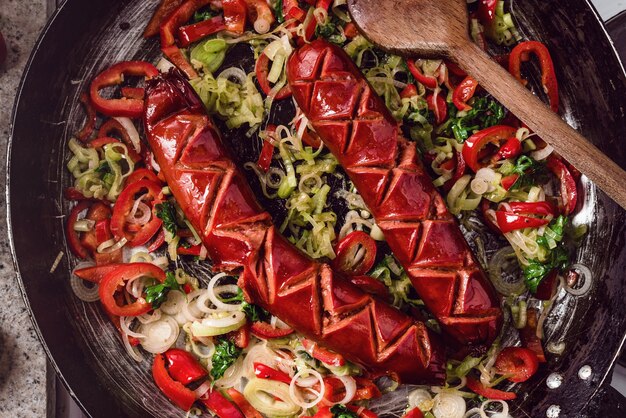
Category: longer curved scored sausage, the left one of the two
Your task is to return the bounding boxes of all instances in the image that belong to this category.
[144,70,445,383]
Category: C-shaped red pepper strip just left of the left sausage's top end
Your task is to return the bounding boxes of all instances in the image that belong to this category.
[89,61,159,118]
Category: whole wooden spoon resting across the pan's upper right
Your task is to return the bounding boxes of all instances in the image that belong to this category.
[348,0,626,209]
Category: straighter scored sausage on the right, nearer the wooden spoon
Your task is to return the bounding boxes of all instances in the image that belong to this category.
[287,40,502,348]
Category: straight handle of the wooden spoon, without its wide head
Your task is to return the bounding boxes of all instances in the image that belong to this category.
[450,41,626,209]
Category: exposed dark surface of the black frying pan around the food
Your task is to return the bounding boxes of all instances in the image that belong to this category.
[7,0,626,417]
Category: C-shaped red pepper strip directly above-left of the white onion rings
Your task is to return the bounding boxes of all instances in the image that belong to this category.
[98,263,165,316]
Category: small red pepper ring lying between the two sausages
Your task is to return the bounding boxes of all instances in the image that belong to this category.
[333,231,376,276]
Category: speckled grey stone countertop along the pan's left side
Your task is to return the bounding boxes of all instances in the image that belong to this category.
[0,0,48,418]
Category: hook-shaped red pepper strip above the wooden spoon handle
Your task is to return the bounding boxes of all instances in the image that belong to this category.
[509,41,559,113]
